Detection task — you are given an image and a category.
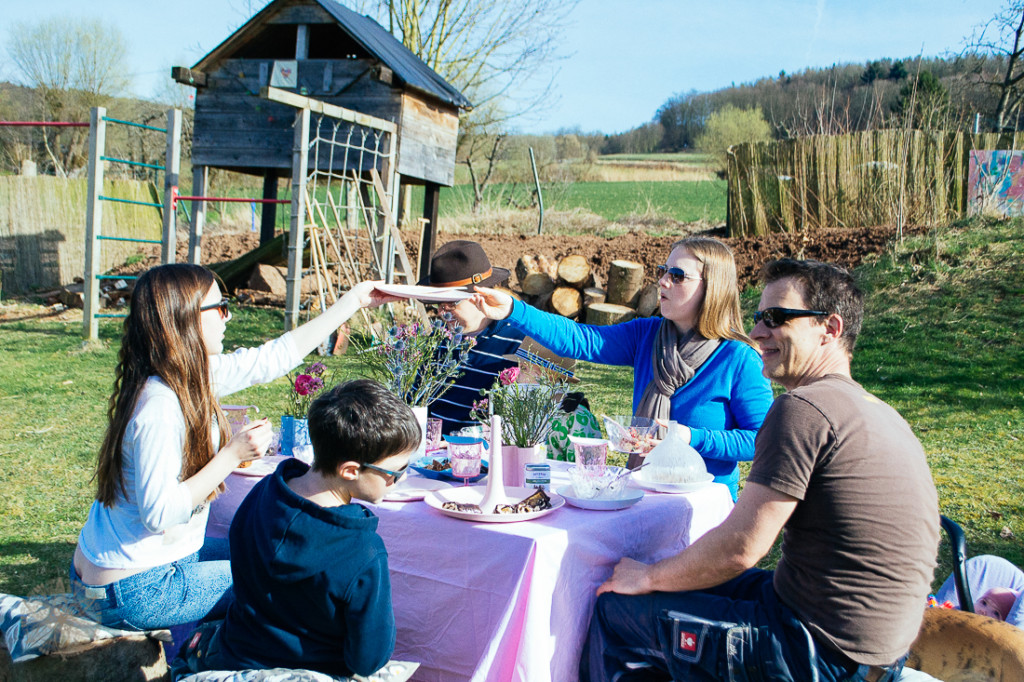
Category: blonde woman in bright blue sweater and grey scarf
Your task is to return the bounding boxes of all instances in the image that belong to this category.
[470,237,772,500]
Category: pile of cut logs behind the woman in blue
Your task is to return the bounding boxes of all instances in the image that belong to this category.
[515,254,658,325]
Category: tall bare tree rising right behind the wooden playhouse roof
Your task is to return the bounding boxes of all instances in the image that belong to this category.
[357,0,579,210]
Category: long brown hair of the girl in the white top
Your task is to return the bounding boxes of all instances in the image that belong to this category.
[95,263,230,507]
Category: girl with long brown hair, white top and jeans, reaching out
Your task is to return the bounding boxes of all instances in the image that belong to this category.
[70,264,393,630]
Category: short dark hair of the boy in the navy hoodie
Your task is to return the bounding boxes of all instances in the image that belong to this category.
[308,379,421,476]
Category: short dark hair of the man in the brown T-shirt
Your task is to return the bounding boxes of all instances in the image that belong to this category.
[761,258,864,354]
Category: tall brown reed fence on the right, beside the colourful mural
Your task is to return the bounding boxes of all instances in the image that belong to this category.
[726,130,1024,237]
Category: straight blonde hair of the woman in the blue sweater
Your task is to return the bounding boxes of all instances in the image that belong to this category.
[672,237,757,349]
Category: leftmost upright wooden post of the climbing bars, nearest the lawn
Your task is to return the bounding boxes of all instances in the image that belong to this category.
[82,106,106,340]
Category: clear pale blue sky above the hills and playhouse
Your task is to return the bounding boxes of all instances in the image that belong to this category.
[0,0,1005,133]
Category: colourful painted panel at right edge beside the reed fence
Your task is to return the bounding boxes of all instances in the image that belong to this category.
[967,150,1024,216]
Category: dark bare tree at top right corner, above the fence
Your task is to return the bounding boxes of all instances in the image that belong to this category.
[965,0,1024,131]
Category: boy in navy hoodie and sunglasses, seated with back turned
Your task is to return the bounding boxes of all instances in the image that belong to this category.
[175,379,420,676]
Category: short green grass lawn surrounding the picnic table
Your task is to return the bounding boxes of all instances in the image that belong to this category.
[0,215,1024,594]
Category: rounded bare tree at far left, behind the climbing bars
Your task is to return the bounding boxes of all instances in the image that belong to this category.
[7,16,130,176]
